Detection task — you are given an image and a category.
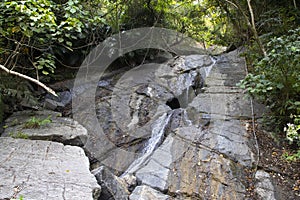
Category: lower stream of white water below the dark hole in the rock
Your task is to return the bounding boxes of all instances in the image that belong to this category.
[122,111,173,176]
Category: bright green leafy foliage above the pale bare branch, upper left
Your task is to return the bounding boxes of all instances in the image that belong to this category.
[0,0,107,77]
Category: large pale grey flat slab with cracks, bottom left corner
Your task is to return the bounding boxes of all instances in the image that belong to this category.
[0,137,101,200]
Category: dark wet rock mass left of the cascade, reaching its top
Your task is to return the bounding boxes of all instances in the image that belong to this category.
[73,55,214,173]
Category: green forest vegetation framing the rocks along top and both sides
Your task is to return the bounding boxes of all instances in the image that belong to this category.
[0,0,300,160]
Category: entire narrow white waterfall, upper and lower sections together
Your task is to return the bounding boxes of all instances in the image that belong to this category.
[121,54,217,177]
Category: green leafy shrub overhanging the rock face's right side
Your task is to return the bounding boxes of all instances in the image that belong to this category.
[240,28,300,127]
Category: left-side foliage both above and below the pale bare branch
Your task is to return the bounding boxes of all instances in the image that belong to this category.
[0,0,109,122]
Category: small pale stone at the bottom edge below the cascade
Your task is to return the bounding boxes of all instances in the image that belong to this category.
[129,185,171,200]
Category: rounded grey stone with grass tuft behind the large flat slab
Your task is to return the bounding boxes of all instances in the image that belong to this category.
[2,110,88,146]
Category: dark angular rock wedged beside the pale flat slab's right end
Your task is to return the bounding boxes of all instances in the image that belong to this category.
[92,166,129,200]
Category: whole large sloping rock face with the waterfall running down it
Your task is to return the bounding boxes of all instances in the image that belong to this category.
[69,50,263,200]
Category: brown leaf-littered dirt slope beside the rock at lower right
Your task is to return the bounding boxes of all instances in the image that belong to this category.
[245,121,300,200]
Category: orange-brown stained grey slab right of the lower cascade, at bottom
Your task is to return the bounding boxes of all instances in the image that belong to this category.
[136,130,245,199]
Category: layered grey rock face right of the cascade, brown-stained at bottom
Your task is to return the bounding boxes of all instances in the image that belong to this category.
[135,49,255,199]
